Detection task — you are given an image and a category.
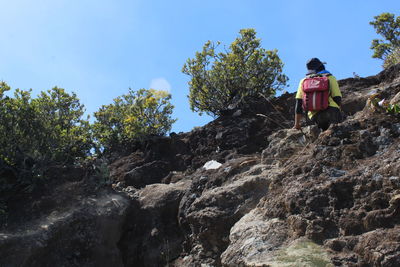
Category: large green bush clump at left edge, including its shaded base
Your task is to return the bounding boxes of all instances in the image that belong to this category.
[0,85,92,201]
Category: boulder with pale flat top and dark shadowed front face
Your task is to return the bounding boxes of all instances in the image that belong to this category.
[118,180,190,266]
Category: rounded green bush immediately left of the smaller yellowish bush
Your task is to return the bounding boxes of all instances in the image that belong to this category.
[32,87,93,162]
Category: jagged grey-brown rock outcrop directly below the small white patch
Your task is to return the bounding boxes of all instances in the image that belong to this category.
[175,157,269,266]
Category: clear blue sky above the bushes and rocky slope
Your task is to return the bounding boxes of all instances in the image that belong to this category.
[0,0,400,132]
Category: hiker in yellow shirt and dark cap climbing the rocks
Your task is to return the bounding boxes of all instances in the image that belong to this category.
[293,58,342,131]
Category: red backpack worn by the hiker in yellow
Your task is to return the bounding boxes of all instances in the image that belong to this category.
[302,76,329,111]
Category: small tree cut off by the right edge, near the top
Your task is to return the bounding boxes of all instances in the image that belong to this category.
[370,13,400,68]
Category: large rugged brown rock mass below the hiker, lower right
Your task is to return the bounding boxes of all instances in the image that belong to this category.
[222,114,400,266]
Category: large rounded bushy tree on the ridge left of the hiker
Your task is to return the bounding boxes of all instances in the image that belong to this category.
[182,29,288,116]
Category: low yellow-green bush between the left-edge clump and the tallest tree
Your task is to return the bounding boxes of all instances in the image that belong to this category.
[93,89,176,154]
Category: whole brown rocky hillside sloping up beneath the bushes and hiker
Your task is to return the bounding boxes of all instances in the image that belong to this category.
[0,65,400,267]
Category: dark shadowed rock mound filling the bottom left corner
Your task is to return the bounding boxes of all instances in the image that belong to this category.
[0,185,130,267]
